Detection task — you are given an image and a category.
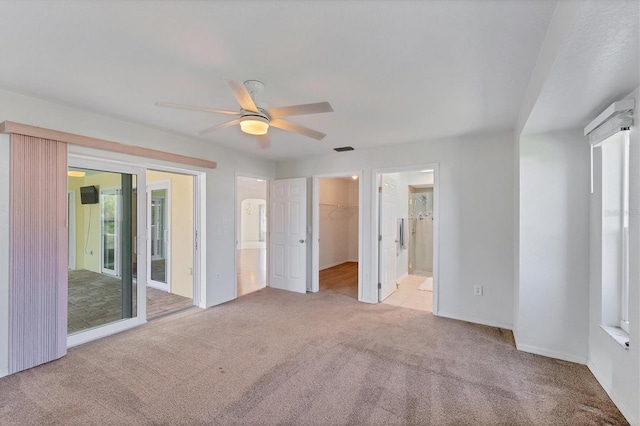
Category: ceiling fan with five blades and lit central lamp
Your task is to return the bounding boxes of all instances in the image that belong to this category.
[156,80,333,148]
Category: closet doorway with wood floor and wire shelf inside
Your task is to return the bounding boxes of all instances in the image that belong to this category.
[311,172,362,300]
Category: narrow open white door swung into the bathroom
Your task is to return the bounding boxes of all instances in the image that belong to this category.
[378,175,398,302]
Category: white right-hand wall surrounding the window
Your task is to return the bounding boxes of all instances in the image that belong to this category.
[585,88,640,424]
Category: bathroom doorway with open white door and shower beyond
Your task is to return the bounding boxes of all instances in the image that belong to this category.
[374,165,438,312]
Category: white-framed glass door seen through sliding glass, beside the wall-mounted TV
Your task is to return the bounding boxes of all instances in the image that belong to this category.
[100,188,122,277]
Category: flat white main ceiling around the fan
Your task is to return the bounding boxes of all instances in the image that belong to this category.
[0,0,588,159]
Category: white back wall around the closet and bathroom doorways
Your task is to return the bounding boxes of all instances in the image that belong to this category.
[277,132,514,328]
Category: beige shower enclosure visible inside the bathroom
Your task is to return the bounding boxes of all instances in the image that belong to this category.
[408,186,433,277]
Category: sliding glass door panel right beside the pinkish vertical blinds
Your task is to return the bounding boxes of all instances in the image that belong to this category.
[67,158,146,339]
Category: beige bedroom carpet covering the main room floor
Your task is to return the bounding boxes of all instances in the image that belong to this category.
[0,288,626,425]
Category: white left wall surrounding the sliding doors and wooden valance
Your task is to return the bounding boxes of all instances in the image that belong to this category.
[0,90,275,372]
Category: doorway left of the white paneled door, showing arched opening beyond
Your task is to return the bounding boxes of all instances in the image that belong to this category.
[236,176,268,297]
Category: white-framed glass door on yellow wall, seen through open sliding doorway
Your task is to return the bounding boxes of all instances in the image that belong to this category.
[147,182,170,292]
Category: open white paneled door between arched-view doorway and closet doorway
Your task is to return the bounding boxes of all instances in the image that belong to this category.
[269,178,307,293]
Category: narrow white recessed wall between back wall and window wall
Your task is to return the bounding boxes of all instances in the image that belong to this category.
[516,129,590,363]
